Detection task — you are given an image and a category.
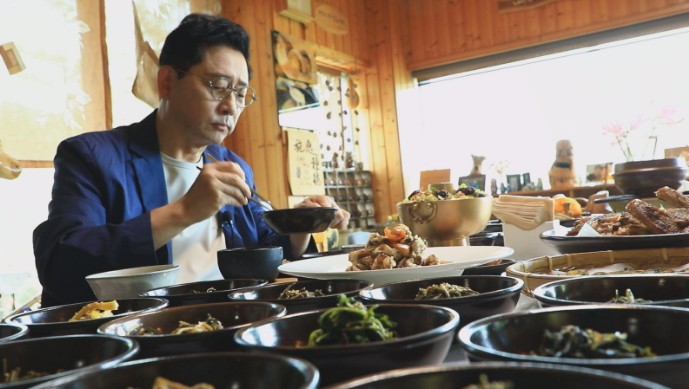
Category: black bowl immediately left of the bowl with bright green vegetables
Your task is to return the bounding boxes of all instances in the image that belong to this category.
[98,301,287,359]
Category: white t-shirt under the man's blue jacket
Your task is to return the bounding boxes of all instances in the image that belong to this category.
[160,153,226,284]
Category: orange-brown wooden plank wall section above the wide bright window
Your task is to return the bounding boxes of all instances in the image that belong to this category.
[398,0,689,70]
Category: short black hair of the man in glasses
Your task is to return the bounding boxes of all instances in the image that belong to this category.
[160,13,251,77]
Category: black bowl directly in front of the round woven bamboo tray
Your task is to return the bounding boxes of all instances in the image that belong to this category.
[532,274,689,308]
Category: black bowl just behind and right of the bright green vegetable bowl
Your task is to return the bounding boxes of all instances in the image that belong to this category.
[359,275,524,327]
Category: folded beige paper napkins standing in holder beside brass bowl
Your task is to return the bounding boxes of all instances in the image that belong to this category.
[493,195,555,230]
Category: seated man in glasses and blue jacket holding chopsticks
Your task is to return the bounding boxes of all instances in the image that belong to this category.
[34,14,349,306]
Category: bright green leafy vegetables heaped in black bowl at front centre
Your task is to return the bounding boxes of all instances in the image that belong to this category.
[308,294,397,346]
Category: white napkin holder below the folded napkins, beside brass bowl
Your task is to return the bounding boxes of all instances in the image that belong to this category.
[502,219,566,261]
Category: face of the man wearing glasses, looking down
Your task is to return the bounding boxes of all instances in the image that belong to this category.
[169,46,249,147]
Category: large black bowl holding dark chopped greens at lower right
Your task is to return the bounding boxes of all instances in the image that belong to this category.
[459,304,689,388]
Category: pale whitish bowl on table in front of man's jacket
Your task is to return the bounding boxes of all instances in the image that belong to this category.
[86,265,179,300]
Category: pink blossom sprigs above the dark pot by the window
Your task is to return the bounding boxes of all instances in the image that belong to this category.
[603,103,684,162]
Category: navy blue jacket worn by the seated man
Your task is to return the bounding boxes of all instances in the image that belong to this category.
[33,111,300,306]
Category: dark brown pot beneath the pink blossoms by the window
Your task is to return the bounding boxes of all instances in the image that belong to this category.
[613,157,689,198]
